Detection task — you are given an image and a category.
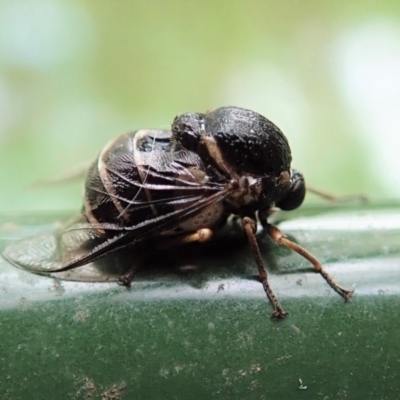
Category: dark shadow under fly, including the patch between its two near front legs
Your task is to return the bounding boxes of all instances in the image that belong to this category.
[82,221,314,288]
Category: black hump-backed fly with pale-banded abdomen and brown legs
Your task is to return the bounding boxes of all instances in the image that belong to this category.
[4,107,352,318]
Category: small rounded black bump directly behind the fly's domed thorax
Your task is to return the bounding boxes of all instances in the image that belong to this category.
[171,113,204,152]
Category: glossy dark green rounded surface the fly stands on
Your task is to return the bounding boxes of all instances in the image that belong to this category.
[0,204,400,399]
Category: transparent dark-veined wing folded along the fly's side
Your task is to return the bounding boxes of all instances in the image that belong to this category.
[3,156,232,281]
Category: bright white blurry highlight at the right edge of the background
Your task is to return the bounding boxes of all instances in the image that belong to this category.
[333,19,400,196]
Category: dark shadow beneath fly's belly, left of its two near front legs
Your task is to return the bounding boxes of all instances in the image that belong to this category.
[93,224,257,288]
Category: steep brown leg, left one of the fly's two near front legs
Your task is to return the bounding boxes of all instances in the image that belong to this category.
[242,217,287,318]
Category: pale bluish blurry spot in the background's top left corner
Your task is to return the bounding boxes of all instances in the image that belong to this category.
[0,0,91,69]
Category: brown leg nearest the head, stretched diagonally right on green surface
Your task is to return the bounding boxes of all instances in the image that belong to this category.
[264,223,353,302]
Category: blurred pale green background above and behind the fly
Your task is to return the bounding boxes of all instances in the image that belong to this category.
[0,0,400,212]
